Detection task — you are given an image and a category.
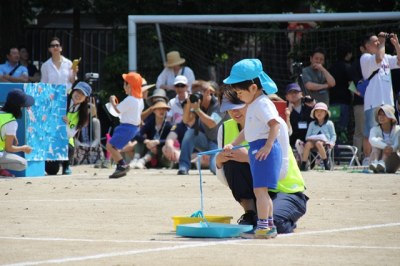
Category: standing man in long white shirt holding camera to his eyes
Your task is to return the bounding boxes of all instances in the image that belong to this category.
[360,32,400,164]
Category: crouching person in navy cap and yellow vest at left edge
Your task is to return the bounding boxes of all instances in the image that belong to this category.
[0,89,35,177]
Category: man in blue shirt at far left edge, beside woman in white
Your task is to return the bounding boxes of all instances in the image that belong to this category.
[0,46,29,83]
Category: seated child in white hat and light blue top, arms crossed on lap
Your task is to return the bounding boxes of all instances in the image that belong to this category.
[300,102,336,171]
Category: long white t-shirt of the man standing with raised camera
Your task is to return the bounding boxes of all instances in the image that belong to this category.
[360,53,400,111]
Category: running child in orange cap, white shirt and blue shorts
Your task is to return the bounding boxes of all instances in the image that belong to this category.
[106,72,144,178]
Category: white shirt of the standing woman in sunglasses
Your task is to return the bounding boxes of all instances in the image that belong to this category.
[40,56,72,91]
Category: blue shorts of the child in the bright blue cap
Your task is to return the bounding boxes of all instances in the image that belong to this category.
[249,139,282,189]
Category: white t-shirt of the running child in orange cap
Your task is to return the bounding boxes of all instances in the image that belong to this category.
[117,95,144,126]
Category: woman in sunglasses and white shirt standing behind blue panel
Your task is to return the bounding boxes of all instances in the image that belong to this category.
[40,37,78,91]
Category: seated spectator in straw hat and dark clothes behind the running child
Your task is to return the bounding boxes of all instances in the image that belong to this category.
[130,101,171,169]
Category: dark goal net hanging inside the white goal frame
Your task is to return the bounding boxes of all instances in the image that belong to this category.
[137,21,400,93]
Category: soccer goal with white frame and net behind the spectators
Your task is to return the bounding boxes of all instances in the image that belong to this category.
[128,12,400,93]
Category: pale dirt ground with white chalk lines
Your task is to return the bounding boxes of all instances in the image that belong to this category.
[0,166,400,265]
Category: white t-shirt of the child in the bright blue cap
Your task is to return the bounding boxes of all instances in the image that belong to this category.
[244,95,279,142]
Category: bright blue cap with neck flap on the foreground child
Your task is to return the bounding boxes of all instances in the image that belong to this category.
[223,58,278,94]
